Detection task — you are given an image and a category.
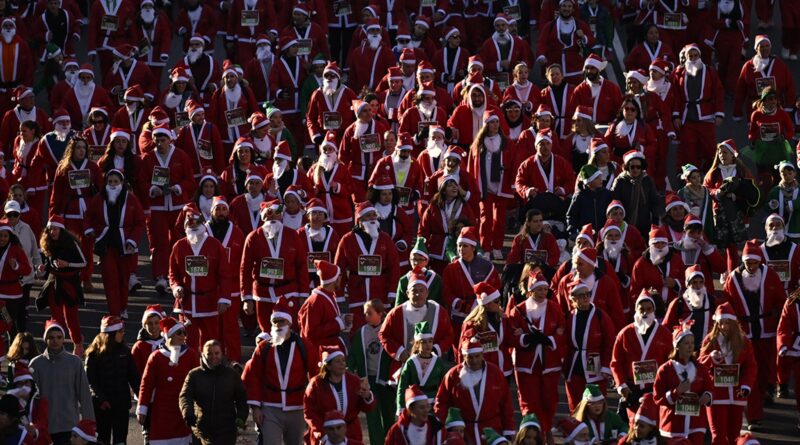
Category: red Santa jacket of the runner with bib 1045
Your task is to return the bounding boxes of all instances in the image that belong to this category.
[610,321,673,390]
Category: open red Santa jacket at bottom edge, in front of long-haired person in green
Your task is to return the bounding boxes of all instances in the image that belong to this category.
[303,372,375,445]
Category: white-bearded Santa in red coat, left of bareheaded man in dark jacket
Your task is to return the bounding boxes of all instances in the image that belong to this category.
[136,317,200,445]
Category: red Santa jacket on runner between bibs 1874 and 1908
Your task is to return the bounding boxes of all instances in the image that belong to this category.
[240,226,308,303]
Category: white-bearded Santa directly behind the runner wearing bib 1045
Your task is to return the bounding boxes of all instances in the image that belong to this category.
[623,226,685,315]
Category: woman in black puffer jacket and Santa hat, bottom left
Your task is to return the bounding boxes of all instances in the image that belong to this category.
[86,315,140,443]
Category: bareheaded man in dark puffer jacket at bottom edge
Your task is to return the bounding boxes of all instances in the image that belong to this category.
[179,340,248,445]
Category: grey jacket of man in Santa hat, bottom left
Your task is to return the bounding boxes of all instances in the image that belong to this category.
[30,349,94,434]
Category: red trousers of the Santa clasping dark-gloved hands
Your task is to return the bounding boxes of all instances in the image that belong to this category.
[514,366,561,431]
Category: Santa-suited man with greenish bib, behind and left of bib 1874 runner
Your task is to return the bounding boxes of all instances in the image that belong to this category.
[139,126,196,293]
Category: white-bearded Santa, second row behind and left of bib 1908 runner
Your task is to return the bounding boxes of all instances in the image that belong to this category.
[309,131,363,236]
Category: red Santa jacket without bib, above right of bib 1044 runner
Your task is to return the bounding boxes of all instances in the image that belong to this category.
[722,264,786,339]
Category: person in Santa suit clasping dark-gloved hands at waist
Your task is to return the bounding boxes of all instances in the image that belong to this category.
[509,270,566,434]
